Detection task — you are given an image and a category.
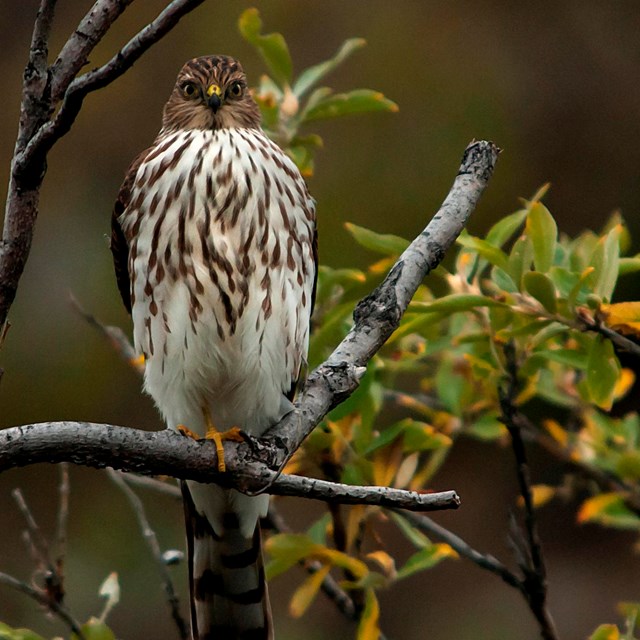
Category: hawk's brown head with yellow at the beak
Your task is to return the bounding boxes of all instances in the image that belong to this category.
[162,56,260,132]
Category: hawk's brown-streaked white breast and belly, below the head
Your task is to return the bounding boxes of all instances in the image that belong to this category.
[120,129,315,433]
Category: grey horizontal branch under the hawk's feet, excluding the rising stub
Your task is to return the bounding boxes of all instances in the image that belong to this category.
[0,422,460,511]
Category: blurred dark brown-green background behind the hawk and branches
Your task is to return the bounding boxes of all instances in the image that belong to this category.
[0,0,640,640]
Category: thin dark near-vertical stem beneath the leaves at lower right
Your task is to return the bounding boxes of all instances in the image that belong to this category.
[498,343,558,640]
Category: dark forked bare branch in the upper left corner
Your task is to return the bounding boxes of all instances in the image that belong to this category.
[0,0,204,335]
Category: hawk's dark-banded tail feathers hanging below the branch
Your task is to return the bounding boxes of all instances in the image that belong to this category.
[182,483,273,640]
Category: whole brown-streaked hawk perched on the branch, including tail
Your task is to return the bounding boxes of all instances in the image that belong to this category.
[111,56,317,640]
